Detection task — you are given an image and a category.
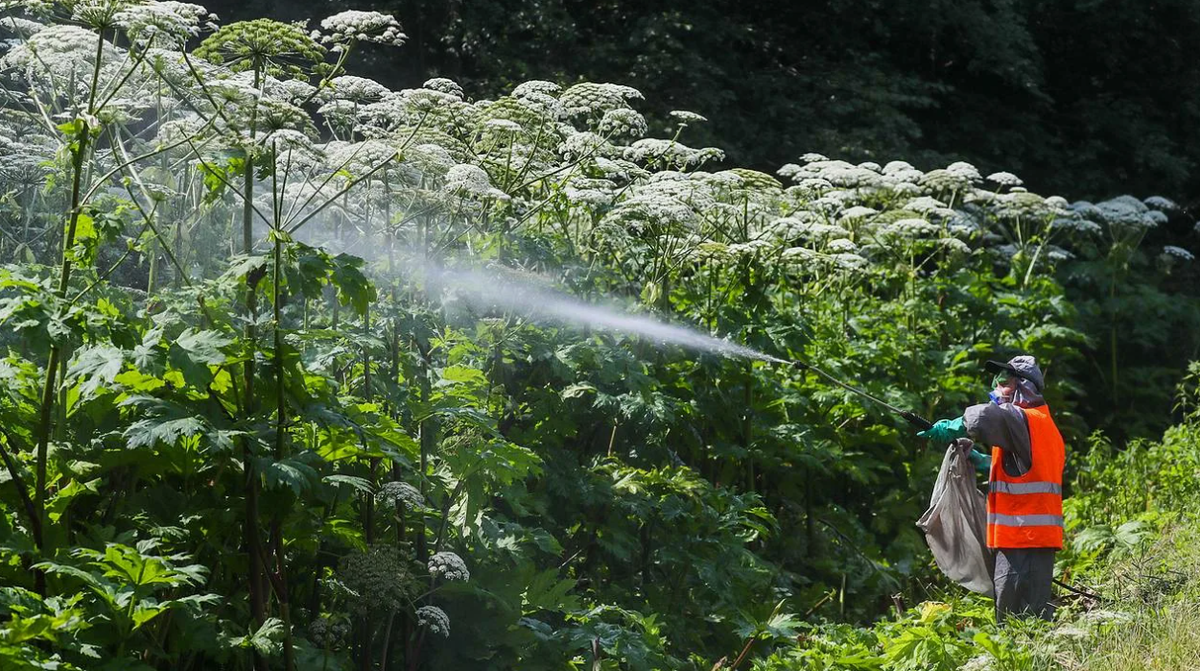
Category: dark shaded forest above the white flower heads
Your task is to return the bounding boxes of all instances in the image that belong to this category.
[208,0,1200,210]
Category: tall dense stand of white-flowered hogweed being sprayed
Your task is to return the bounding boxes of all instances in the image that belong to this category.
[0,0,1193,670]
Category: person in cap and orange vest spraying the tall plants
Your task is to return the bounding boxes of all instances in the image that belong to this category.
[918,357,1066,622]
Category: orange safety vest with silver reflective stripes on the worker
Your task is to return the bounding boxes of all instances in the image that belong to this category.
[988,406,1067,550]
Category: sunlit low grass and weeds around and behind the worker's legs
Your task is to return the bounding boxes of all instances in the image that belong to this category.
[752,419,1200,671]
